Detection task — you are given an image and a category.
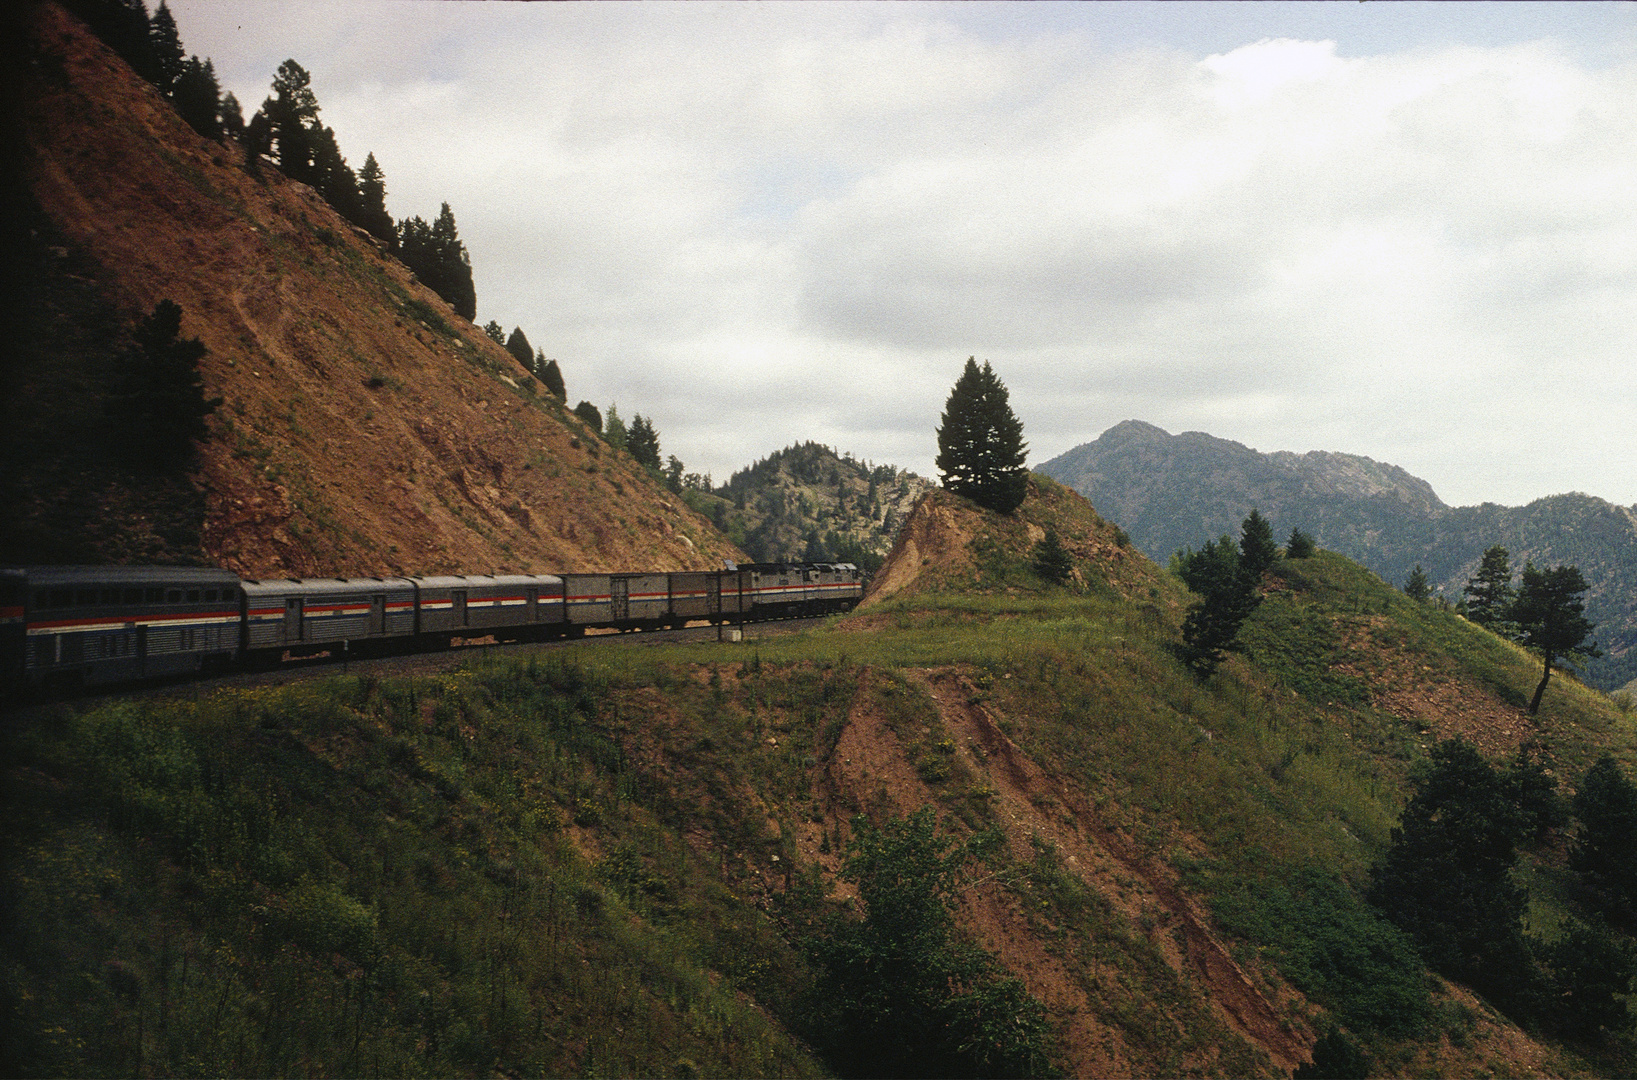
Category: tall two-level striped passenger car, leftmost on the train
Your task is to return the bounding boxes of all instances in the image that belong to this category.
[0,566,239,686]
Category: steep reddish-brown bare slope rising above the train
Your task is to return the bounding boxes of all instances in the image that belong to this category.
[5,3,743,576]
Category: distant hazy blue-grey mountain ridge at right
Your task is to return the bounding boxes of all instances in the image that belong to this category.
[1039,421,1637,687]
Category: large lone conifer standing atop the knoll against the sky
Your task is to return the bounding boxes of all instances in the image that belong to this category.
[936,357,1028,514]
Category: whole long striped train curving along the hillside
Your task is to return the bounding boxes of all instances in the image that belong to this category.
[0,563,863,687]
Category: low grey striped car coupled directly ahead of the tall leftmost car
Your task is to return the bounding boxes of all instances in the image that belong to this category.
[244,578,416,655]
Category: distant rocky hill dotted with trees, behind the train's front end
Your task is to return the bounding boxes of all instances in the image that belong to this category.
[684,442,933,571]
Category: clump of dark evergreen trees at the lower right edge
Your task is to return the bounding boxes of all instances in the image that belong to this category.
[1369,738,1637,1042]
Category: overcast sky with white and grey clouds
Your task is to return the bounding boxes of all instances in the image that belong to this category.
[170,0,1637,506]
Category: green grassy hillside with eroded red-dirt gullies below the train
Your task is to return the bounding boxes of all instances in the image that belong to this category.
[3,489,1637,1075]
